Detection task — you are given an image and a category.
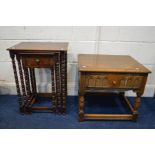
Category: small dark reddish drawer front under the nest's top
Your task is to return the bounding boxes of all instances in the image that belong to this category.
[22,56,55,68]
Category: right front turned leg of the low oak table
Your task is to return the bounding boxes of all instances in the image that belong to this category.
[133,92,142,121]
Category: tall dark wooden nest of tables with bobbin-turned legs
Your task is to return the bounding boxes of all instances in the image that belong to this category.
[8,42,68,113]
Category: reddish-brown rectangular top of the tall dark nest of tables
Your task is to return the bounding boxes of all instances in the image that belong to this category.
[7,42,68,52]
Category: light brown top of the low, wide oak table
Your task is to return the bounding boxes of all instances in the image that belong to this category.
[78,54,151,73]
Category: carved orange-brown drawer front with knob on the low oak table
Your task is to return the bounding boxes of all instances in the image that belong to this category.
[86,74,143,89]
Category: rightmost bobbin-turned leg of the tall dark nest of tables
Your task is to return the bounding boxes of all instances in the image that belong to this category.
[61,52,67,113]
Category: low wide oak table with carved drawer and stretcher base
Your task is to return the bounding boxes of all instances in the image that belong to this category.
[78,54,150,121]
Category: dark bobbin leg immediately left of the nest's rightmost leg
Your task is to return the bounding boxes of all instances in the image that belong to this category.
[55,54,61,113]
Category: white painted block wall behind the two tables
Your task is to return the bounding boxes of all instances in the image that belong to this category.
[0,26,155,96]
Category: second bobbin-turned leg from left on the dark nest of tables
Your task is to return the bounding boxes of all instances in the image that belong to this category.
[17,55,27,112]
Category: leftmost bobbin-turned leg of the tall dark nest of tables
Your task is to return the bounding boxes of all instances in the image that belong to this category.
[10,53,24,113]
